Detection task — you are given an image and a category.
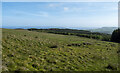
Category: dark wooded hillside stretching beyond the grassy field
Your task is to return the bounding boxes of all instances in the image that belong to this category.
[28,28,111,41]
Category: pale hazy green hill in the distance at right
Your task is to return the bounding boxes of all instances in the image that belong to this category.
[90,27,117,34]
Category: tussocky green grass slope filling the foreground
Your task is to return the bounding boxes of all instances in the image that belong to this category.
[2,29,118,71]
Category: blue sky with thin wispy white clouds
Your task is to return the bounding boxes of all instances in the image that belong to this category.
[2,2,118,27]
